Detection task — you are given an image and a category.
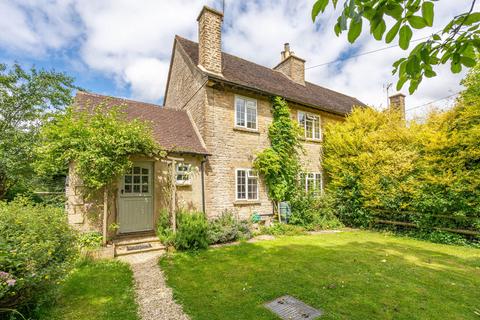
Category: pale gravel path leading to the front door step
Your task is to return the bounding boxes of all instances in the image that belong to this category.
[121,253,189,320]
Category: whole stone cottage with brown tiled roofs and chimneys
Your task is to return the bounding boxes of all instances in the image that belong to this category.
[67,7,403,240]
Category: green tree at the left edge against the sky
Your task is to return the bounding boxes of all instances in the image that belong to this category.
[0,63,75,199]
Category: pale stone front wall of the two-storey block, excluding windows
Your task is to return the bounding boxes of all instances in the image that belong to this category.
[204,87,343,218]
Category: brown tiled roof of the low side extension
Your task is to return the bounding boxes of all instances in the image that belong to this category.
[75,91,208,155]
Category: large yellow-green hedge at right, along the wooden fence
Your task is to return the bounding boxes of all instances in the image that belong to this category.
[324,63,480,238]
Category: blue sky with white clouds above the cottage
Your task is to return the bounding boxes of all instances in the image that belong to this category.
[0,0,471,117]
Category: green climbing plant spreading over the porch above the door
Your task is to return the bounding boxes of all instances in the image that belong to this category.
[35,104,164,190]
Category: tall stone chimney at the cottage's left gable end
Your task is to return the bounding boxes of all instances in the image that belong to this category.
[197,6,223,75]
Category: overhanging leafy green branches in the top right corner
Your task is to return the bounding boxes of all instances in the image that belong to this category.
[312,0,480,93]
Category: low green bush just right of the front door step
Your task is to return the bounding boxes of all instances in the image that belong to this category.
[157,210,208,250]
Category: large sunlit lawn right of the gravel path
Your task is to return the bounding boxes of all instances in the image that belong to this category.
[160,231,480,320]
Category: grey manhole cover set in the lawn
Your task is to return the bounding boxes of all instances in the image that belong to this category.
[265,296,323,320]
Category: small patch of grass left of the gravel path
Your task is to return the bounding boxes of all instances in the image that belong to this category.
[40,260,138,320]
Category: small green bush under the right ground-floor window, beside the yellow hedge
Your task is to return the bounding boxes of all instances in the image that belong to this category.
[289,192,342,230]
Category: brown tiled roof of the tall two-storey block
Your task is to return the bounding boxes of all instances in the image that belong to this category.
[175,36,365,114]
